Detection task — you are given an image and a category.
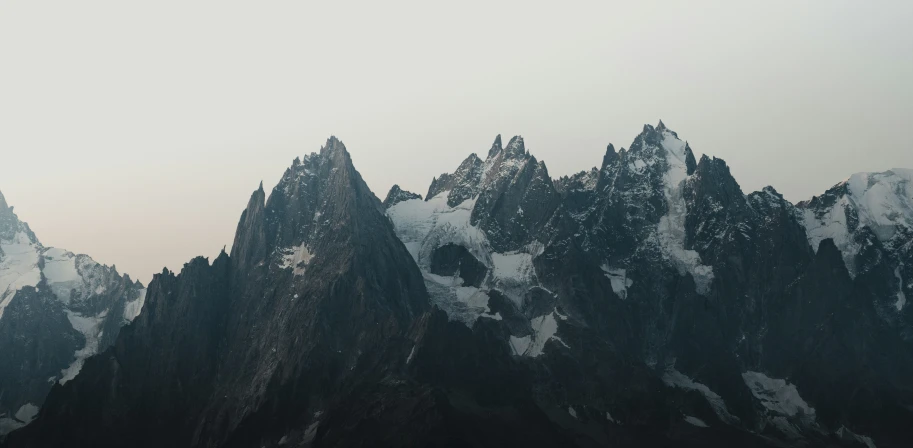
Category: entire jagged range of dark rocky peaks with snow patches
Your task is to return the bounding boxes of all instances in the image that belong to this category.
[0,122,913,448]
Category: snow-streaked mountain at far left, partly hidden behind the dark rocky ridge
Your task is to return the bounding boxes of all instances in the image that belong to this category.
[0,189,145,434]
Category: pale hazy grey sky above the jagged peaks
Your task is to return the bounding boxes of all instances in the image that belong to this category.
[0,0,913,281]
